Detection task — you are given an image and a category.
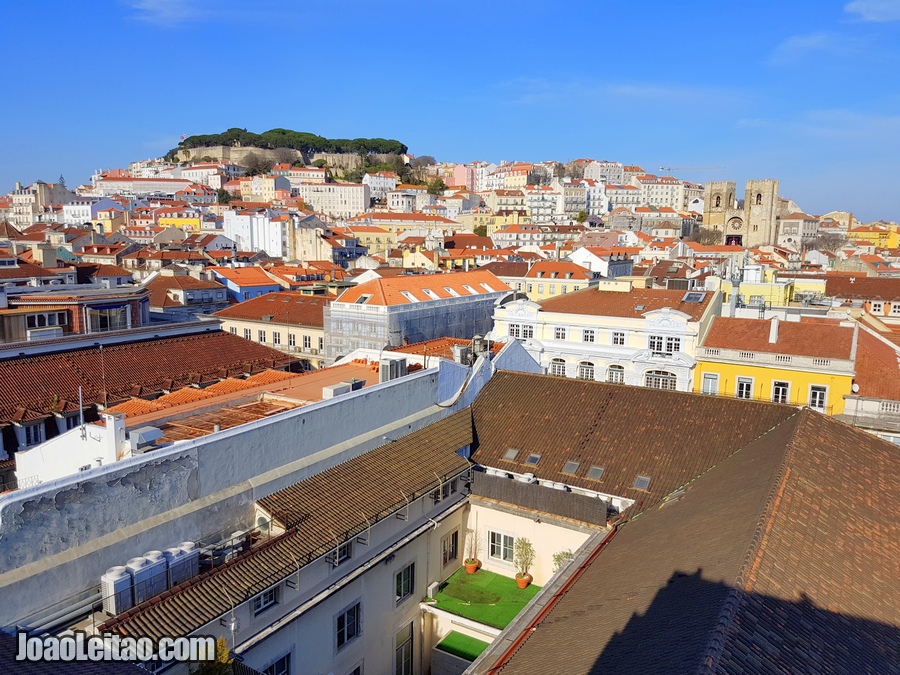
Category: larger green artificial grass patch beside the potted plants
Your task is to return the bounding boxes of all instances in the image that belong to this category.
[435,568,541,628]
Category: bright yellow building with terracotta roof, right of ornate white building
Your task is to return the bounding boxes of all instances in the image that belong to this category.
[693,317,858,415]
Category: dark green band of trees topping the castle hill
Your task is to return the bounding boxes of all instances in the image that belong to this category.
[169,128,408,156]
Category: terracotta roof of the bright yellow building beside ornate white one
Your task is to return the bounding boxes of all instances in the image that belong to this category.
[703,316,853,359]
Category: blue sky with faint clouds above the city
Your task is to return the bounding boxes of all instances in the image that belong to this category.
[0,0,900,221]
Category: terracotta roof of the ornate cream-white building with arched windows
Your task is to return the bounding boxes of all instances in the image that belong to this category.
[538,288,715,321]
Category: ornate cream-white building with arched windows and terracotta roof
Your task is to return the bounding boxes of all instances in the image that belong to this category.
[492,281,722,391]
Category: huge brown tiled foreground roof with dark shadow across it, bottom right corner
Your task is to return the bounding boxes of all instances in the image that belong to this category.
[492,410,900,675]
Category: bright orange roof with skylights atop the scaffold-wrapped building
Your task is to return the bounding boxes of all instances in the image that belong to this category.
[336,270,512,305]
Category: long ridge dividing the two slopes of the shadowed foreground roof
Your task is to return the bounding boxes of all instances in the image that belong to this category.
[697,409,812,675]
